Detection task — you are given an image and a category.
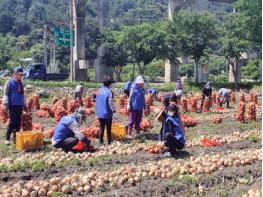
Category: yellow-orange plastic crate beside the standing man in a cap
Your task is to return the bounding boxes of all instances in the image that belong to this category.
[16,131,44,151]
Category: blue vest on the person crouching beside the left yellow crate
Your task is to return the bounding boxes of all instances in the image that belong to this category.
[53,115,77,142]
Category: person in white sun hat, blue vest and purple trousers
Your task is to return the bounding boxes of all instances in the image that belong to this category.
[127,75,145,137]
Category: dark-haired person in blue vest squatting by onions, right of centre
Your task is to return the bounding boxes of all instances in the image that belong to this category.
[160,103,185,157]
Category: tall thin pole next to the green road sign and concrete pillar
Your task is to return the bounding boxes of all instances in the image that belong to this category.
[69,0,75,81]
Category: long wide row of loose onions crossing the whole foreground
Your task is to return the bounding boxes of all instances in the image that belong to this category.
[0,149,261,196]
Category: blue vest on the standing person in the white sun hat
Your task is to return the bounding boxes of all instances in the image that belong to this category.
[130,85,145,111]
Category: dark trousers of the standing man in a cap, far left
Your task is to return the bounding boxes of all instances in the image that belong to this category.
[6,106,23,142]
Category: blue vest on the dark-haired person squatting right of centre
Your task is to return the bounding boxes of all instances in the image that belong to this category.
[162,115,185,144]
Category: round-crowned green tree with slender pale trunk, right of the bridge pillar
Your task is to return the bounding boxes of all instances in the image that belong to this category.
[171,11,217,82]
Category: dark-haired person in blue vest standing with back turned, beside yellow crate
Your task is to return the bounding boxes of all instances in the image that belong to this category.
[96,76,116,145]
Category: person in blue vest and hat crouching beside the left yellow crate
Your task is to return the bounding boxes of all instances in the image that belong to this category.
[52,108,90,152]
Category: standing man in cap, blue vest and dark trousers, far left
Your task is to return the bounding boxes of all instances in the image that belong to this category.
[3,67,26,146]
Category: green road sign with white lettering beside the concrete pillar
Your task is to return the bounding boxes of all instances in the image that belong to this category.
[54,27,75,46]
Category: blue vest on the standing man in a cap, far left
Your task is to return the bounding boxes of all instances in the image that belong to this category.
[8,79,24,106]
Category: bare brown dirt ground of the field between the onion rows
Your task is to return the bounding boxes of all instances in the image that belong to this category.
[0,89,262,197]
